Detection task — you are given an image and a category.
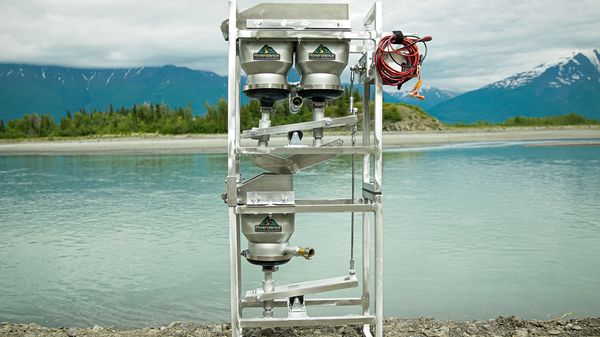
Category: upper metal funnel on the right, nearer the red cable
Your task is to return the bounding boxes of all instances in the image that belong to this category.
[296,40,350,100]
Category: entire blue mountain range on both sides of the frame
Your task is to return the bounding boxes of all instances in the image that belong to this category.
[0,49,600,123]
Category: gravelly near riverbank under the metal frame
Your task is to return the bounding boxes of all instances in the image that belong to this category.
[0,317,600,337]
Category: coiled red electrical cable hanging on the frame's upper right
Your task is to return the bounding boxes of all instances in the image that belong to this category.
[375,35,431,95]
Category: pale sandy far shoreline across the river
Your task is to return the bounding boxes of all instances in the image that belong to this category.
[0,126,600,156]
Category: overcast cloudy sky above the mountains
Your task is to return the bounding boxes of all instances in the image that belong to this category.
[0,0,600,91]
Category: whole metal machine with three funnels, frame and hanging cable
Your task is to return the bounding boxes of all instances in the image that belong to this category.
[221,0,428,337]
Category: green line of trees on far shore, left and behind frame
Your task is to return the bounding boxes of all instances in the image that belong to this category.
[0,90,360,138]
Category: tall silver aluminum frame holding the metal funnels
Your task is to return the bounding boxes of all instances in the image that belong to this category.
[226,0,383,337]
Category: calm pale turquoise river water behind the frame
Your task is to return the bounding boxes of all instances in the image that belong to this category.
[0,143,600,327]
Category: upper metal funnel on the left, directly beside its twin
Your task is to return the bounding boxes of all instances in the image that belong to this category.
[240,40,294,106]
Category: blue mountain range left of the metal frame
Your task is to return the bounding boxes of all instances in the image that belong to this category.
[0,64,227,120]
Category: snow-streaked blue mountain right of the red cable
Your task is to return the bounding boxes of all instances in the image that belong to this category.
[431,49,600,123]
